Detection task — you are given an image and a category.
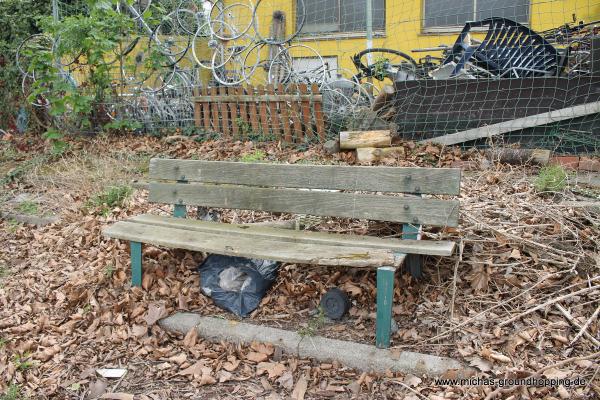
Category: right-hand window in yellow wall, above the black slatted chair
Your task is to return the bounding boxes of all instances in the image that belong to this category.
[424,0,530,28]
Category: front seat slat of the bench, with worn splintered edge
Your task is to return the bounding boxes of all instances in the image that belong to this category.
[104,221,404,268]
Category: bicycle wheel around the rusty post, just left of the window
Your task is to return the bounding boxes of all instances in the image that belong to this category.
[253,0,306,45]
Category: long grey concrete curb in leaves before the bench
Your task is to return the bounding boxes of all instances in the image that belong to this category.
[159,313,471,376]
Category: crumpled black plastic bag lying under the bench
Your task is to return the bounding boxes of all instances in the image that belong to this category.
[198,254,281,317]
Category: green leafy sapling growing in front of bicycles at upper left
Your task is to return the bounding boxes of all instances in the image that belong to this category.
[29,0,168,141]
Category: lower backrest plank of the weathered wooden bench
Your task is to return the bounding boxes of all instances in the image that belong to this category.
[149,183,459,226]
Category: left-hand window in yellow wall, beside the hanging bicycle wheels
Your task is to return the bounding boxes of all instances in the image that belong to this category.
[296,0,385,33]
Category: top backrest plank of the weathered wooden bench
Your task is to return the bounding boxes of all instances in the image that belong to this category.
[150,158,461,195]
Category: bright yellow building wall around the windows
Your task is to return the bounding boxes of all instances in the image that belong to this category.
[234,0,600,81]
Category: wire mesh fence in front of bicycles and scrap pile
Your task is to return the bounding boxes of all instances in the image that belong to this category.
[17,0,600,154]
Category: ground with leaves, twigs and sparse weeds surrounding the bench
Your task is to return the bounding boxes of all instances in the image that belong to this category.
[0,136,600,400]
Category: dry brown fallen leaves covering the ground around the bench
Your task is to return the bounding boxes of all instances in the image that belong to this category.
[0,133,600,400]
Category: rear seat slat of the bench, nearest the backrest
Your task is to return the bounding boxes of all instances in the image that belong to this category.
[128,214,455,256]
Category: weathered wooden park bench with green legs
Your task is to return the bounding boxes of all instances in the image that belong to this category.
[104,159,460,347]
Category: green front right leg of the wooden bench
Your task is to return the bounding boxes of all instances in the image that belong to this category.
[375,267,396,349]
